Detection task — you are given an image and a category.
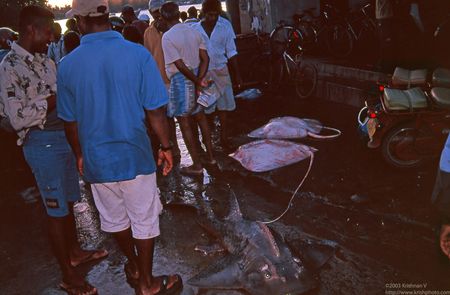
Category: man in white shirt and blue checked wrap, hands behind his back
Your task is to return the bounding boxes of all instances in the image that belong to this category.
[161,2,215,175]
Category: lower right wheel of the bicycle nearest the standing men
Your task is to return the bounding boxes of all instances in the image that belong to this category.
[294,63,317,99]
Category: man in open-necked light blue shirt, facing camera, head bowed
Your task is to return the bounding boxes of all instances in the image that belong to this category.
[192,0,242,149]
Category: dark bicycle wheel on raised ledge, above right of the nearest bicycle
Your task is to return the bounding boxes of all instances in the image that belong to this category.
[325,24,353,58]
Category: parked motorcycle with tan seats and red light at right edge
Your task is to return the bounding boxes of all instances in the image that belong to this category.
[358,67,450,168]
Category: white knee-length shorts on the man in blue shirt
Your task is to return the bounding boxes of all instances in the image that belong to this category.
[91,173,162,240]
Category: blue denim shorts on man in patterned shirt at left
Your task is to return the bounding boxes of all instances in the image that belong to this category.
[23,130,80,217]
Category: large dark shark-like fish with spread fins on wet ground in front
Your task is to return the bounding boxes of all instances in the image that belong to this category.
[188,191,335,295]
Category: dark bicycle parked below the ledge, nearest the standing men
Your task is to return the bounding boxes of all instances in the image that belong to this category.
[269,22,317,99]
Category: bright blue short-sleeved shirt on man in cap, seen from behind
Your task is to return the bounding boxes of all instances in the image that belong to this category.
[58,31,167,182]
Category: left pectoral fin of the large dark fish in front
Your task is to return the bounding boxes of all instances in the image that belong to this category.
[188,255,243,289]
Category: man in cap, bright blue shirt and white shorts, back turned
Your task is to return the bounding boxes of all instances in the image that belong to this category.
[57,0,182,294]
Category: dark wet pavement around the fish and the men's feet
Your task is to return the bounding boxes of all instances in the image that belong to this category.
[0,94,450,295]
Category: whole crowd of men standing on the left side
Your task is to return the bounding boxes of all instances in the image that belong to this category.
[0,0,241,295]
